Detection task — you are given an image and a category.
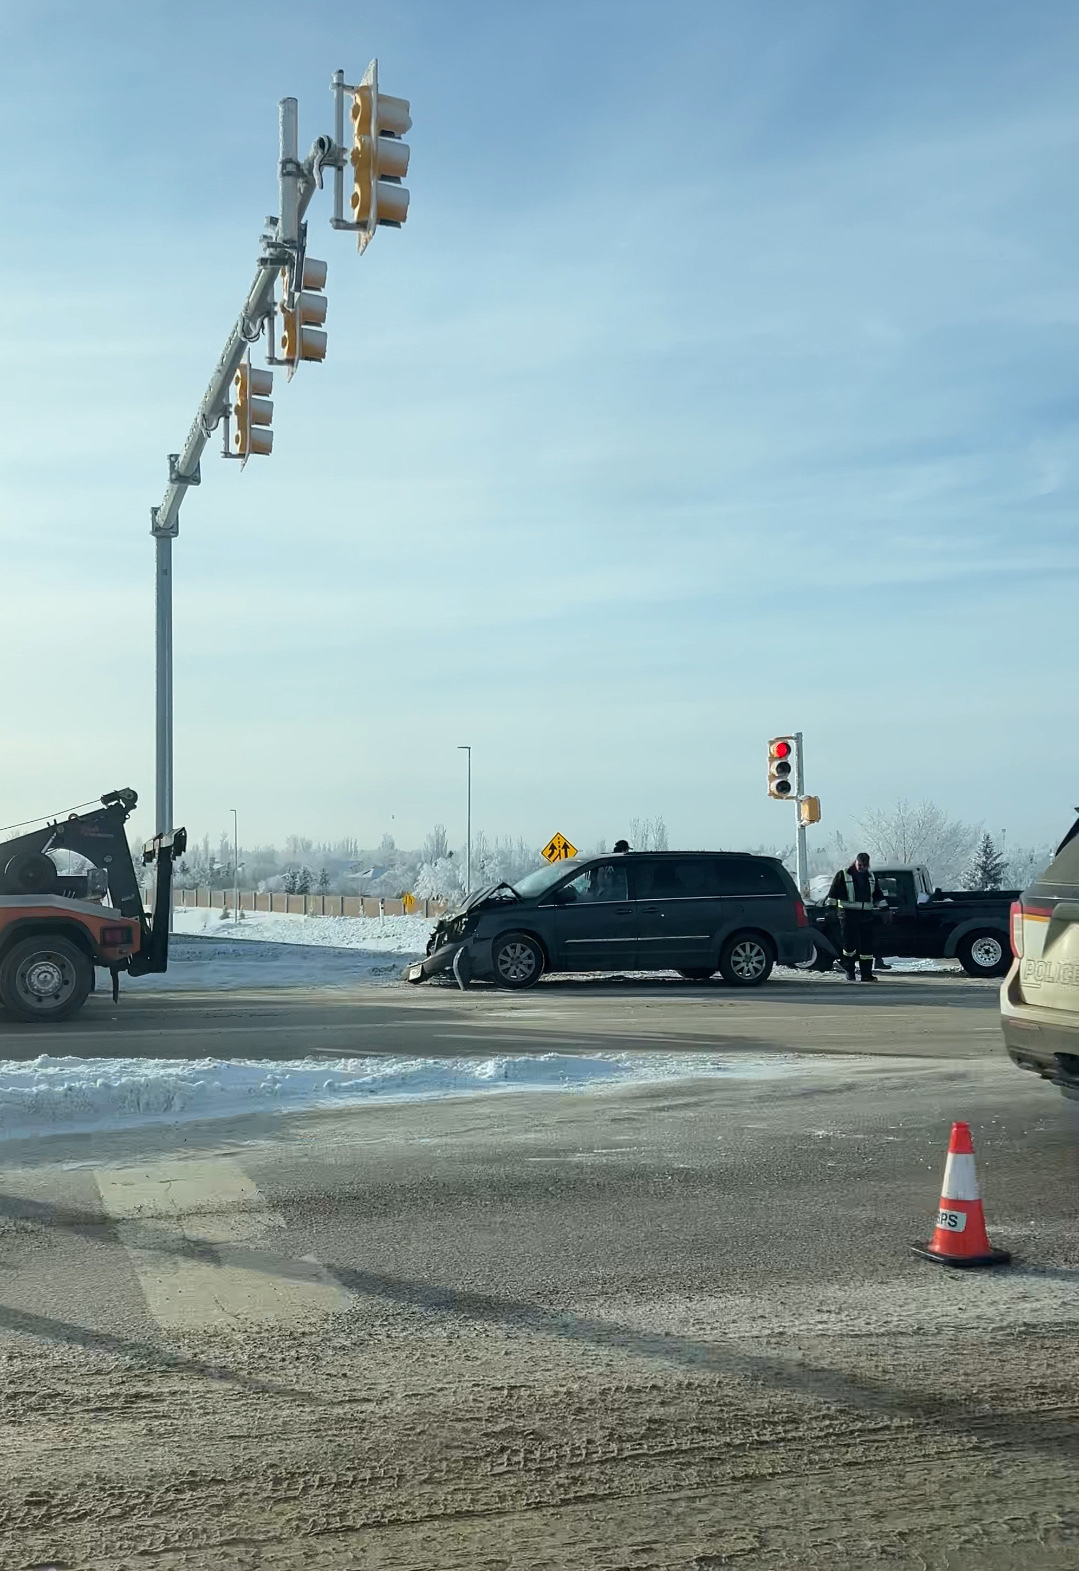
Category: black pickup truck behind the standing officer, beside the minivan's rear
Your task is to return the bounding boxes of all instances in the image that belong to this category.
[807,867,1019,977]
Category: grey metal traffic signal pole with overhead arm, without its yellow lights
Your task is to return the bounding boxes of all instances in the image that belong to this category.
[151,97,332,834]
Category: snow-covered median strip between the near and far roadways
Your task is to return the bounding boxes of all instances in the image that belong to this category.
[0,1053,803,1141]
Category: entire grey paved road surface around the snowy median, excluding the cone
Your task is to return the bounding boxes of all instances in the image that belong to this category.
[0,979,1079,1571]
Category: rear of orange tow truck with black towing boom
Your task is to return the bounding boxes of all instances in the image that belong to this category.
[0,787,187,1021]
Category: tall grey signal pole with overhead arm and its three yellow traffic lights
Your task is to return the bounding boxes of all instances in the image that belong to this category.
[151,60,411,834]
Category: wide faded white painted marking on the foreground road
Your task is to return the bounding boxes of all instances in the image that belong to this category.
[96,1156,350,1331]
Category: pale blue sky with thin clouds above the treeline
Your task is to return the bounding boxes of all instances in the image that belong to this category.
[0,0,1079,845]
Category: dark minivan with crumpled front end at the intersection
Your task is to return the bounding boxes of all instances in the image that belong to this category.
[405,851,812,988]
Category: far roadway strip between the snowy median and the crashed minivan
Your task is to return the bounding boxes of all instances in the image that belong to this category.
[0,972,1000,1059]
